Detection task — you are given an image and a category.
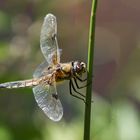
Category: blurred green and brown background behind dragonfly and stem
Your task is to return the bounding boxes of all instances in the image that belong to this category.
[0,0,140,140]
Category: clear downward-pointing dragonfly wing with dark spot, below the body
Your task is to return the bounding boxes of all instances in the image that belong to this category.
[33,85,63,121]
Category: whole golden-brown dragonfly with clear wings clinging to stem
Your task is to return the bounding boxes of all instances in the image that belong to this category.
[0,13,87,121]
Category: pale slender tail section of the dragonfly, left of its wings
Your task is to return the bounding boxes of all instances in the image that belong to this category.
[0,79,38,88]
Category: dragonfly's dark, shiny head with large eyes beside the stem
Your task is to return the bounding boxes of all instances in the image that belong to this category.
[73,61,86,75]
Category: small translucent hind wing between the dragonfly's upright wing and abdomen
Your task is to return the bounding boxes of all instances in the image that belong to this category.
[33,61,48,78]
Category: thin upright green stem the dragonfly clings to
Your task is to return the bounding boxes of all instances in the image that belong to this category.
[84,0,98,140]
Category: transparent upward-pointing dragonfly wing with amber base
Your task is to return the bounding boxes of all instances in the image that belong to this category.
[40,14,60,65]
